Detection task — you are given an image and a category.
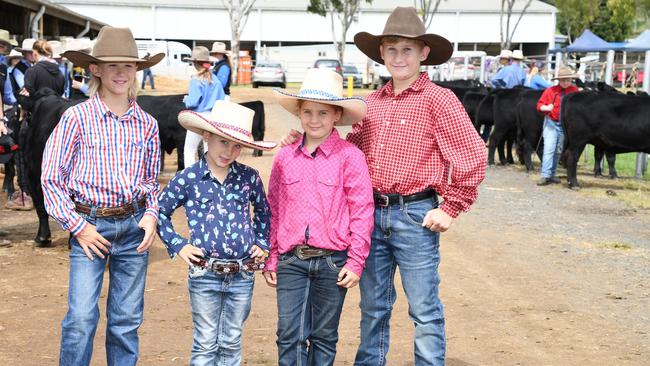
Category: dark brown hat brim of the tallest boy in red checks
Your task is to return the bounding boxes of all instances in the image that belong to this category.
[354,32,454,65]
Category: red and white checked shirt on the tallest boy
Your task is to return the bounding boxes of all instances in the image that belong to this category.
[347,73,486,217]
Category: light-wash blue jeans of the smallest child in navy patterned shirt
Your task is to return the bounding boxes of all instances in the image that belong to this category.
[188,272,255,366]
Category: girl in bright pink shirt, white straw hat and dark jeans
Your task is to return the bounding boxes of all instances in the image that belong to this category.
[264,69,374,366]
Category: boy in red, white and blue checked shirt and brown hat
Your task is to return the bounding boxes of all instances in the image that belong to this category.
[41,26,164,366]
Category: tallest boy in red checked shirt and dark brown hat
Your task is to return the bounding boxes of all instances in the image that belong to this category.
[285,7,486,366]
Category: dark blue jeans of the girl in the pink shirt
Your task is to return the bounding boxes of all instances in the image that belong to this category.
[277,252,347,366]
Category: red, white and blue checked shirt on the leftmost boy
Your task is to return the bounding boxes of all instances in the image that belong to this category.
[41,95,160,234]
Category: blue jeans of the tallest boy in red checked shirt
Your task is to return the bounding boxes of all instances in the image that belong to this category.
[355,198,445,366]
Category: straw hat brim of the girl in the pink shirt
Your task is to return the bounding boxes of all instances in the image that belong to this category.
[273,88,368,126]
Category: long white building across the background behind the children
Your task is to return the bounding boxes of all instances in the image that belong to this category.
[51,0,557,54]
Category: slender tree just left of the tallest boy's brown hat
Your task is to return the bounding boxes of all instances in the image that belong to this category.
[307,0,372,63]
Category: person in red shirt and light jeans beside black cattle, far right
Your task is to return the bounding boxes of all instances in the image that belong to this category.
[537,66,578,186]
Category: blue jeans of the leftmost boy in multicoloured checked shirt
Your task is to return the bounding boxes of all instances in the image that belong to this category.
[59,208,149,366]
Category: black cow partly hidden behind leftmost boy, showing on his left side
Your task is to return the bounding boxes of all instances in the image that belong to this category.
[20,88,80,246]
